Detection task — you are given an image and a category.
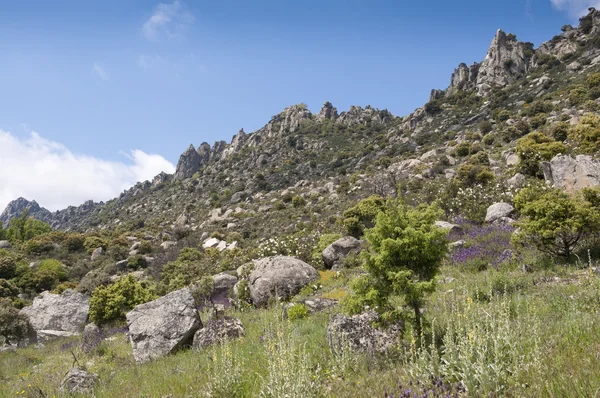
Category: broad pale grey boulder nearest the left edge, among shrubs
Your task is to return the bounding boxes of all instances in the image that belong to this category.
[21,289,90,333]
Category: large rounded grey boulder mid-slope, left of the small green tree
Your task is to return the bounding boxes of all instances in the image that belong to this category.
[248,256,319,306]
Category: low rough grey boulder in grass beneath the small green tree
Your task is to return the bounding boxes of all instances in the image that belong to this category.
[327,311,403,353]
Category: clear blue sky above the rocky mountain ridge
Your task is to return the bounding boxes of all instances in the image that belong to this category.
[0,0,600,207]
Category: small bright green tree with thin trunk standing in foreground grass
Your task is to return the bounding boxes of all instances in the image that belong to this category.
[344,201,448,336]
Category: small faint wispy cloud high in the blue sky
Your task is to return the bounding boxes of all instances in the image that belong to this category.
[142,0,194,41]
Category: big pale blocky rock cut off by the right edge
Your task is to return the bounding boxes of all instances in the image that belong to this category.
[541,155,600,193]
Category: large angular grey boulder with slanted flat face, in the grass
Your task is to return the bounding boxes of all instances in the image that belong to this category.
[126,288,202,362]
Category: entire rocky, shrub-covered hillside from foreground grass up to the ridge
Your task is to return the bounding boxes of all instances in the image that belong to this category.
[0,9,600,398]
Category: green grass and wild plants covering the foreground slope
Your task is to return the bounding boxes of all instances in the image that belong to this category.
[0,266,600,398]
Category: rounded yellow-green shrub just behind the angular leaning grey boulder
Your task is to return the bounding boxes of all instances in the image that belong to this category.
[90,275,155,325]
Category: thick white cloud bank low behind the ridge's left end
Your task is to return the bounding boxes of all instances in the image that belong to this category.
[0,130,175,212]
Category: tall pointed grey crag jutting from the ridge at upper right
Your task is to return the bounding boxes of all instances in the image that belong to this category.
[476,29,533,96]
